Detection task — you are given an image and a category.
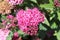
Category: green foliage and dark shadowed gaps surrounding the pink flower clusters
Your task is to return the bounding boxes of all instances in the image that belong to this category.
[0,0,60,40]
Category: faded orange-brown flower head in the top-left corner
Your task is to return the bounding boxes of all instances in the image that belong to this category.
[0,1,13,14]
